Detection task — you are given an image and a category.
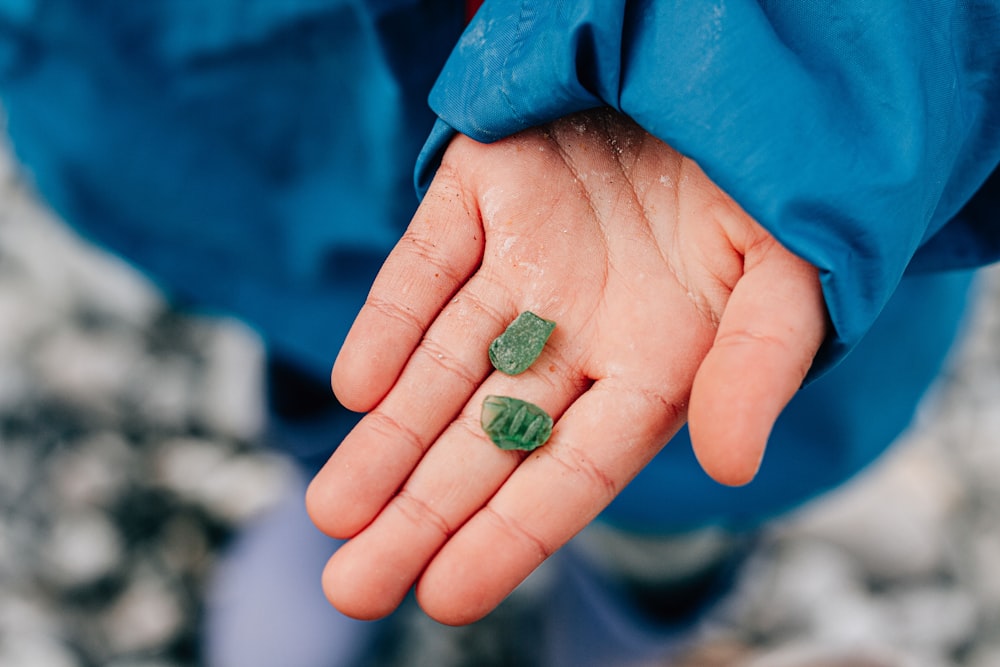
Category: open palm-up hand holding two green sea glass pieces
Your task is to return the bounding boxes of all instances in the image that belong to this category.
[307,111,826,623]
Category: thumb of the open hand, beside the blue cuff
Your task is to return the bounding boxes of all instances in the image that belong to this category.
[689,242,827,486]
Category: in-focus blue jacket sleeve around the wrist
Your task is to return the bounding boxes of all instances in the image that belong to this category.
[417,0,1000,377]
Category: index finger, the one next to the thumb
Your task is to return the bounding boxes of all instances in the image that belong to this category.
[417,380,686,625]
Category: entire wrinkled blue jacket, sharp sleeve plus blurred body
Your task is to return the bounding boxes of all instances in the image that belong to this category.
[0,0,1000,531]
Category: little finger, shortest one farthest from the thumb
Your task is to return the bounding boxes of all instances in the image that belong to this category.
[331,168,483,412]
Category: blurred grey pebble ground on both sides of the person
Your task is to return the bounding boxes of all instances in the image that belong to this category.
[0,133,1000,667]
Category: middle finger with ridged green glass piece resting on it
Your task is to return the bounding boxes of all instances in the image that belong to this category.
[323,357,584,619]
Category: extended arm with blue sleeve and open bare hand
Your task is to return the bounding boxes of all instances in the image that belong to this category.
[309,0,1000,622]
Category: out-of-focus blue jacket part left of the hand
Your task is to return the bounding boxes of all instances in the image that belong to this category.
[0,0,462,377]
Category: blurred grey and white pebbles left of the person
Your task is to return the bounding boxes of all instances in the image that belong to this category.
[0,138,288,667]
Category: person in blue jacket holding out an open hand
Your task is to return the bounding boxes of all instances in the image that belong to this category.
[0,0,1000,665]
